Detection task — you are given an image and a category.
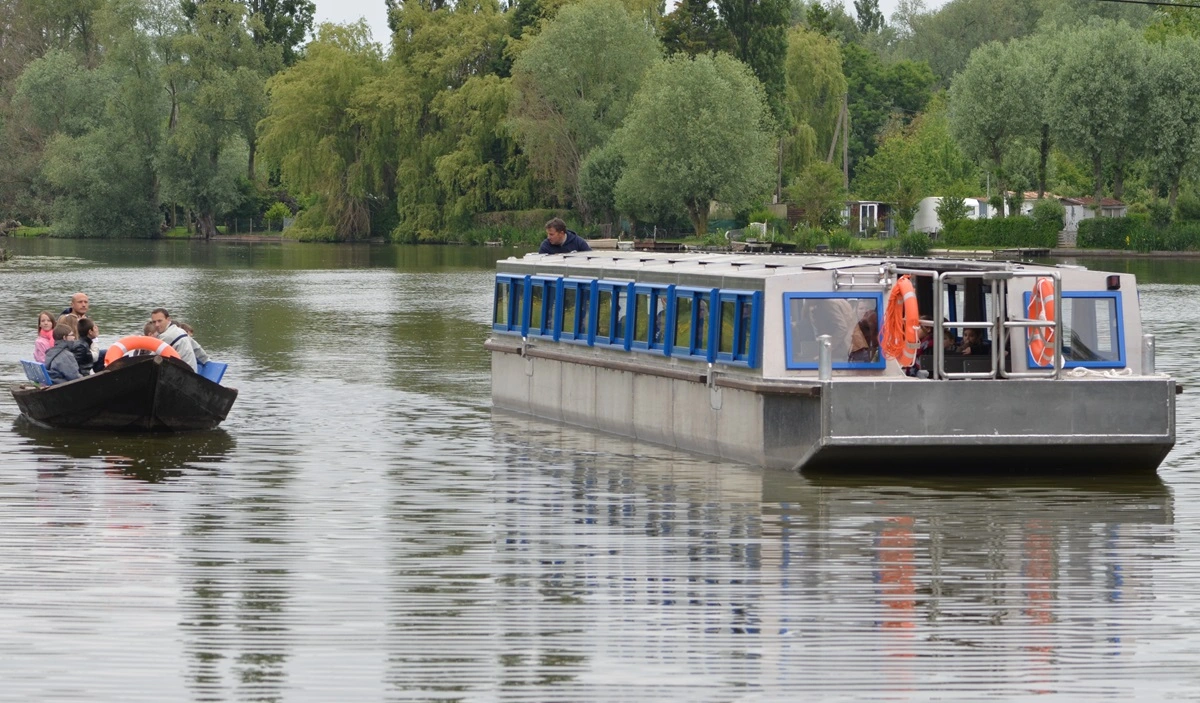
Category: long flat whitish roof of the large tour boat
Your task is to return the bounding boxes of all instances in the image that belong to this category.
[497,250,1081,282]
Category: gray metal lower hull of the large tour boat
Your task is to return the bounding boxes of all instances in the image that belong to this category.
[491,346,1176,474]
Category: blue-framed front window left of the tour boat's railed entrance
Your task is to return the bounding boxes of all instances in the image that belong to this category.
[784,293,887,369]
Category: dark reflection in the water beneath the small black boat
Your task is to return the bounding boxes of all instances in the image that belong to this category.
[13,415,236,483]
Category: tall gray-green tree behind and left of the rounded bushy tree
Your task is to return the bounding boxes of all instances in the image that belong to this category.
[509,0,661,211]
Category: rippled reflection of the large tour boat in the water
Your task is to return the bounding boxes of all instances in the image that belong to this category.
[493,411,1174,695]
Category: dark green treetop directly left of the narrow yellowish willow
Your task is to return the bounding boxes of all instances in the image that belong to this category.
[716,0,791,125]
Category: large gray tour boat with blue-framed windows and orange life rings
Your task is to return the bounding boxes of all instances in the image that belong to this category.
[486,251,1177,473]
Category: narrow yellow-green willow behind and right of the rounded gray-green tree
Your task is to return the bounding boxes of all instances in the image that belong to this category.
[784,26,846,182]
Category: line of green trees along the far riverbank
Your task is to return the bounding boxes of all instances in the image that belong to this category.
[0,0,1200,241]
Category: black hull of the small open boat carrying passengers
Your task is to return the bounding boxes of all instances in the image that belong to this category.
[12,356,238,432]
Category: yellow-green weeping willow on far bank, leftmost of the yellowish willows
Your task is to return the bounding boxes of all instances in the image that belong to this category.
[258,20,392,239]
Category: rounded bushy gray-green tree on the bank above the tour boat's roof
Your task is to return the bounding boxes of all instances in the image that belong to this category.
[613,54,775,235]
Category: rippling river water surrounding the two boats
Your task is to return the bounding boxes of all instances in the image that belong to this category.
[0,240,1200,702]
